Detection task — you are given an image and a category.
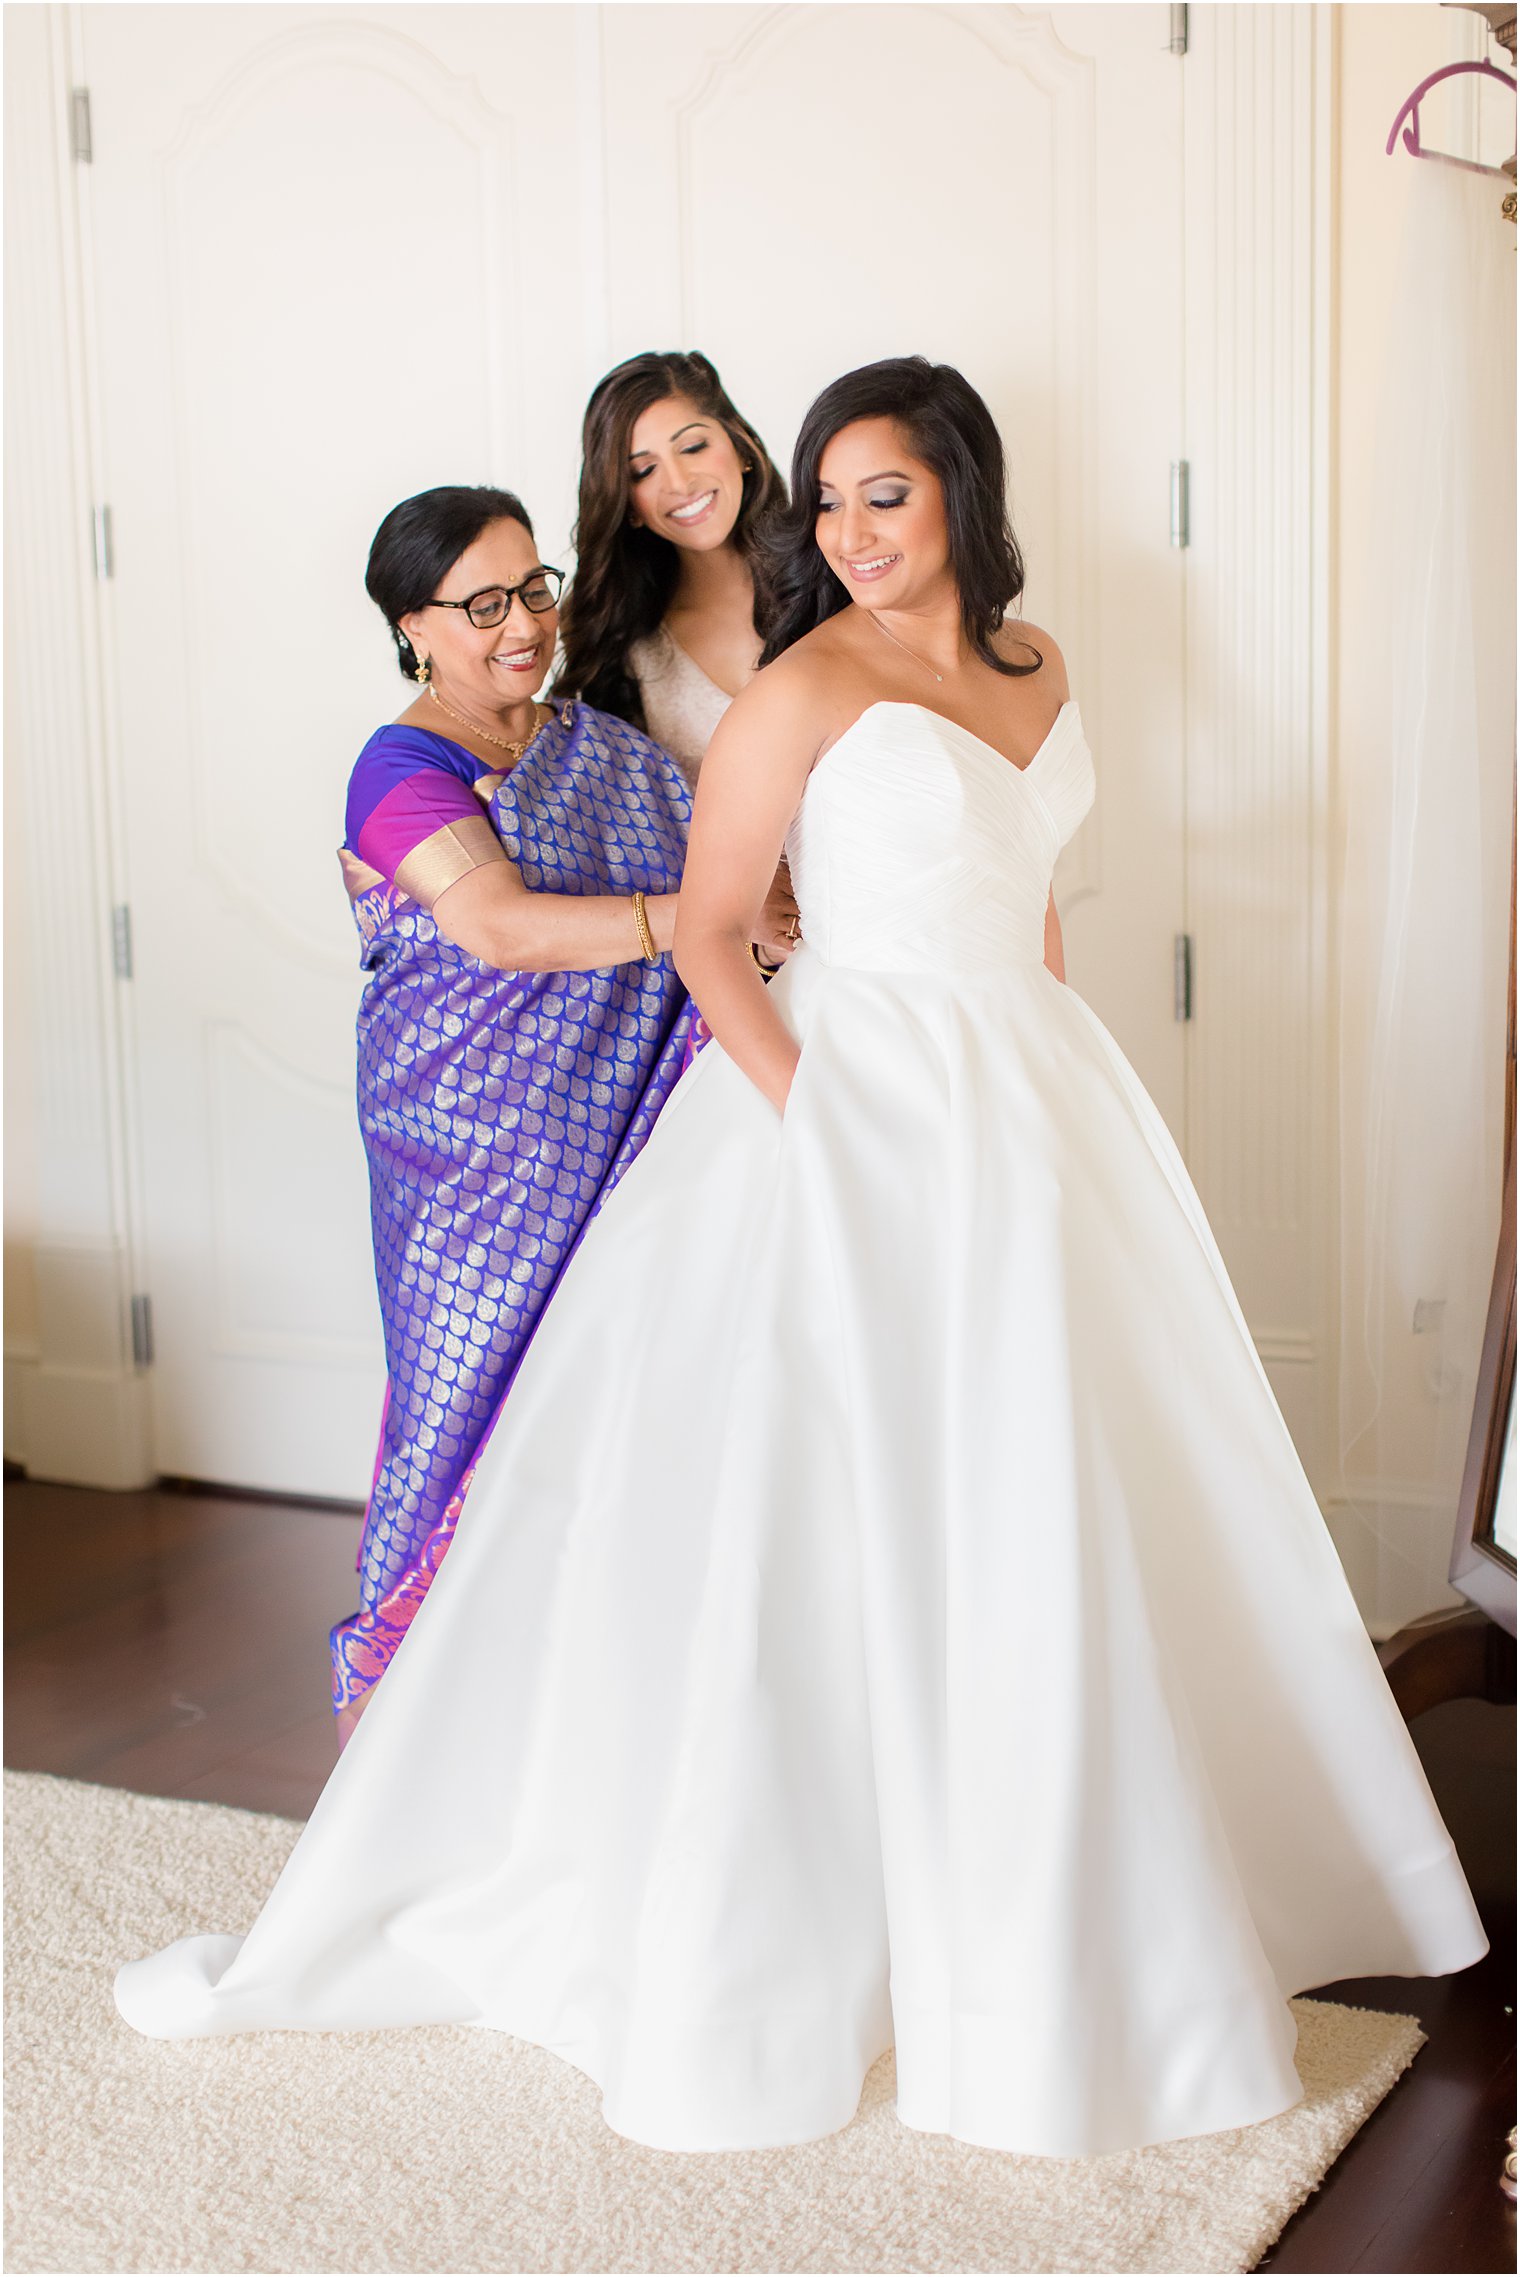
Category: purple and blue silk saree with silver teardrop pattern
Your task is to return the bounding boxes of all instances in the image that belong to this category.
[332,704,694,1710]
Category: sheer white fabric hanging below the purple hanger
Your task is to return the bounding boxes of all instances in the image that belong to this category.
[1340,162,1515,1635]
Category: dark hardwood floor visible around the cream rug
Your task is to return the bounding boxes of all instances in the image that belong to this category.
[5,1480,1515,2272]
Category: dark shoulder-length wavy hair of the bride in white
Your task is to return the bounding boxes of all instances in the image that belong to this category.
[755,355,1044,679]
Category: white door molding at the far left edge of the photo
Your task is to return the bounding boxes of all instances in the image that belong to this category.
[5,7,152,1487]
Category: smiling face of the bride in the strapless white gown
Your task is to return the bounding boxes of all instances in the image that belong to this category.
[815,419,953,608]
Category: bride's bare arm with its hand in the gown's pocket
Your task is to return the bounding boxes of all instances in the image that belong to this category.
[676,665,819,1111]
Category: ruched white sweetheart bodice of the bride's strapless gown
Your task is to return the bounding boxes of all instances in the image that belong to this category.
[787,704,1094,975]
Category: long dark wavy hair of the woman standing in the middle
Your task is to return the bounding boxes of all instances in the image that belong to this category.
[555,351,787,726]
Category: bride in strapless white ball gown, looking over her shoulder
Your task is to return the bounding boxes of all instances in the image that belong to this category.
[116,360,1484,2156]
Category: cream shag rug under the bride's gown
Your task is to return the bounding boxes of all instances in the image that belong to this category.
[5,1772,1422,2272]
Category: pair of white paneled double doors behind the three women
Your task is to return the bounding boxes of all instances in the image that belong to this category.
[80,0,1183,1496]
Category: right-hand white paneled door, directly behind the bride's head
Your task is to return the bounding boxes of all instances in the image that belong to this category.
[601,5,1183,1083]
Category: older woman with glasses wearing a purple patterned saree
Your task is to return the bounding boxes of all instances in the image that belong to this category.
[332,487,792,1737]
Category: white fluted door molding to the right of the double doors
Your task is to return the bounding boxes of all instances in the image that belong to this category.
[1183,7,1333,1480]
